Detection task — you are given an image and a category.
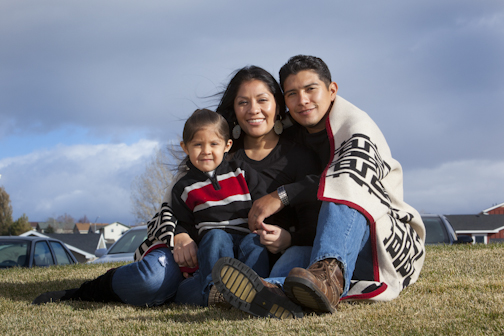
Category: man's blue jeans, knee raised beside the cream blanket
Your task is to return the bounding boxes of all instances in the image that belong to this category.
[265,202,372,296]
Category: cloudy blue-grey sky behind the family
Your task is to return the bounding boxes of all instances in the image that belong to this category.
[0,0,504,225]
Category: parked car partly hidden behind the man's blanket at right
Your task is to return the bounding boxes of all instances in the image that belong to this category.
[422,215,472,245]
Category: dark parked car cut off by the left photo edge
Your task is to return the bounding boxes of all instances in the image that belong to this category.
[0,236,77,268]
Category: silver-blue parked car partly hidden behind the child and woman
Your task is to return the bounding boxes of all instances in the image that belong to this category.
[88,225,147,264]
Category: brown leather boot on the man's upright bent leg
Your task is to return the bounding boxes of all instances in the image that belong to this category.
[284,259,344,313]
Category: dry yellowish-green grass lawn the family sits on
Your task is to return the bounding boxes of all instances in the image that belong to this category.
[0,244,504,336]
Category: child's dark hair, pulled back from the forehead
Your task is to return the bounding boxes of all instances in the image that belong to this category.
[182,109,230,144]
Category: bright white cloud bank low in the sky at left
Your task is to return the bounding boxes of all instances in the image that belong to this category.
[0,140,159,225]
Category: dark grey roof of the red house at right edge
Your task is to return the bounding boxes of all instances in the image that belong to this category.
[445,215,504,233]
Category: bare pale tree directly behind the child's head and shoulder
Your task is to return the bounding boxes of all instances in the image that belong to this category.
[131,147,174,223]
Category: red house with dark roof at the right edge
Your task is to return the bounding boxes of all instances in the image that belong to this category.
[445,214,504,244]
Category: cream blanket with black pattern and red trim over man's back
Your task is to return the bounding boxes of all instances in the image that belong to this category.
[318,96,425,301]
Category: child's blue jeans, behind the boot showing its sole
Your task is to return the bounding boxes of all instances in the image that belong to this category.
[174,229,269,306]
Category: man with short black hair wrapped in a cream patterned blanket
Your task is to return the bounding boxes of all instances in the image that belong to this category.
[213,55,425,317]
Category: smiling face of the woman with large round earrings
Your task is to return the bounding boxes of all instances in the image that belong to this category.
[234,79,276,138]
